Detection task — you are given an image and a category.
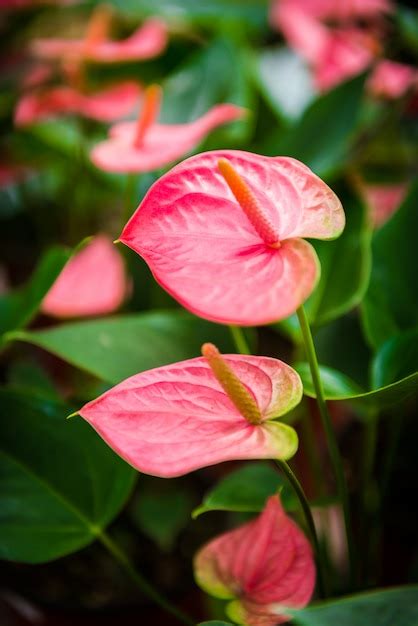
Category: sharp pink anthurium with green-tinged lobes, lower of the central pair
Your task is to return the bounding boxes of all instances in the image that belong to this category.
[79,344,302,478]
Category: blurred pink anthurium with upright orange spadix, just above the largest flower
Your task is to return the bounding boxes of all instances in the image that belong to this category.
[91,85,245,173]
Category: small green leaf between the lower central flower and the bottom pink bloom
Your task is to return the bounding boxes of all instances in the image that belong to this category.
[192,462,298,518]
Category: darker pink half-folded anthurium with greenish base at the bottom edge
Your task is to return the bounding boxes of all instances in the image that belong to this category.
[194,495,315,626]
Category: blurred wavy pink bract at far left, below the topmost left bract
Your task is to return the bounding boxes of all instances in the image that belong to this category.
[15,81,141,126]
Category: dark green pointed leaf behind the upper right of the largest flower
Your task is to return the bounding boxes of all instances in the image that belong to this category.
[261,76,364,176]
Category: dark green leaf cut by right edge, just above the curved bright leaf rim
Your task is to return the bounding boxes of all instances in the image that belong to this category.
[372,328,418,388]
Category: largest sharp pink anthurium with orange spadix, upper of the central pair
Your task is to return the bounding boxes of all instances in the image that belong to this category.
[120,150,345,326]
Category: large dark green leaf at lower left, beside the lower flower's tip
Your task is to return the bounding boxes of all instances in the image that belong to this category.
[0,389,136,563]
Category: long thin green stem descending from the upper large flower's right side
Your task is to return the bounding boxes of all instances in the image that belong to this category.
[297,306,356,584]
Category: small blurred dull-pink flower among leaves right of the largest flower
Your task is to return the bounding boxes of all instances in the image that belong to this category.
[360,182,408,228]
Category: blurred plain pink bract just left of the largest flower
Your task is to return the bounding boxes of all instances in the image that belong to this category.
[41,235,128,318]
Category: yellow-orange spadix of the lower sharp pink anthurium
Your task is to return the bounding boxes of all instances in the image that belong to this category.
[202,343,263,424]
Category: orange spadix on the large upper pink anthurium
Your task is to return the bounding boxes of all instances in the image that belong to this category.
[218,158,280,248]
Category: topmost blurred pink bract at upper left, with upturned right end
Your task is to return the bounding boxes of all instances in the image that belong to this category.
[32,19,168,63]
